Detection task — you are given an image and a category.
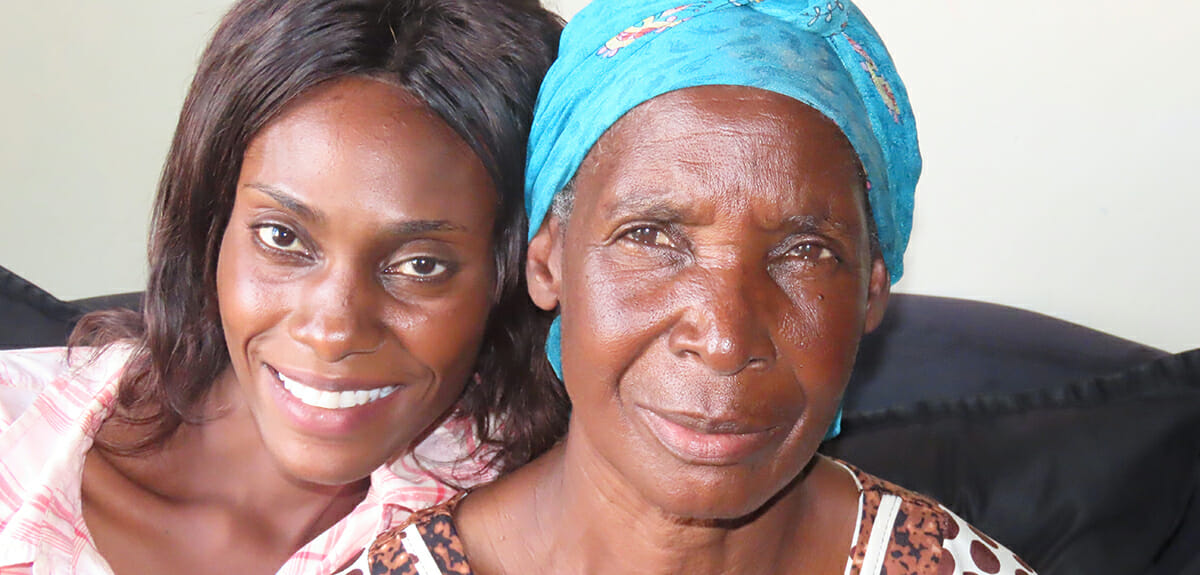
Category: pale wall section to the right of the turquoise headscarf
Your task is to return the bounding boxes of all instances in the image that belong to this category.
[844,0,1200,351]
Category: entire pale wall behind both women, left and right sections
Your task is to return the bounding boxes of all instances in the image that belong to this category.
[0,0,1200,351]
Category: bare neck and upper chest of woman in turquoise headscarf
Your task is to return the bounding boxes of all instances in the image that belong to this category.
[458,427,857,575]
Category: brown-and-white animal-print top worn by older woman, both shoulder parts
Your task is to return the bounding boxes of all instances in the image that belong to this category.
[352,461,1037,575]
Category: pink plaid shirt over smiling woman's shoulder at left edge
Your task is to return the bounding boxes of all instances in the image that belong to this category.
[0,347,128,573]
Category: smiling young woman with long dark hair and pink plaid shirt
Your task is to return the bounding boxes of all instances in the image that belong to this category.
[0,0,564,574]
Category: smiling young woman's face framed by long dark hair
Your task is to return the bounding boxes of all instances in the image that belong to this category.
[217,78,497,485]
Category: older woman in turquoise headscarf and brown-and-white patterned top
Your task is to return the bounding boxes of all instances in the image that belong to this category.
[372,0,1032,575]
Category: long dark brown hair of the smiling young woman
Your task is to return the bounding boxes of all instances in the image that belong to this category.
[70,0,569,469]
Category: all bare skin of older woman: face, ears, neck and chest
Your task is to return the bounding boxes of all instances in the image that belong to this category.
[457,86,888,574]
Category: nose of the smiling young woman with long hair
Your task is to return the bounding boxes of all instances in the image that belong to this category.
[289,266,384,363]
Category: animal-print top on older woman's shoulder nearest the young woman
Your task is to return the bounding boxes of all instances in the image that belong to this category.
[367,493,474,575]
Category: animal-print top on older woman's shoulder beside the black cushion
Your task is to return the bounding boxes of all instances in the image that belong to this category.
[838,462,1036,575]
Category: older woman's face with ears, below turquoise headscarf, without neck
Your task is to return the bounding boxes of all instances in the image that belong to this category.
[529,86,888,519]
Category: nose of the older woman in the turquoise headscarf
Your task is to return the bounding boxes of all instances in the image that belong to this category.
[670,268,775,376]
